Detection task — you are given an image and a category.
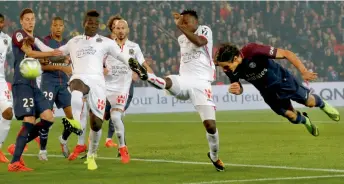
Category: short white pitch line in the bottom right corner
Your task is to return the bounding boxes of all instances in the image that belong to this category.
[183,175,344,184]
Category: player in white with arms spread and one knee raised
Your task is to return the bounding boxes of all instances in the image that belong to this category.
[35,10,147,170]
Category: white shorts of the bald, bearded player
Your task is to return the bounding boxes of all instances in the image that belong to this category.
[106,90,129,111]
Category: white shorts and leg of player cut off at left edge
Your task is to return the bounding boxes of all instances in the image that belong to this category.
[0,82,13,163]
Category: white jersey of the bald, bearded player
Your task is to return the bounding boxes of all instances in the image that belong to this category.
[105,40,145,92]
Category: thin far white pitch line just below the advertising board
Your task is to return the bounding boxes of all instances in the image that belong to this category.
[130,120,339,124]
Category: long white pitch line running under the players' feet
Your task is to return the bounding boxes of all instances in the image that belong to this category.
[19,154,344,173]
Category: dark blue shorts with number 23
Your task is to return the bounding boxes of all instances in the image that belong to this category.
[12,84,50,120]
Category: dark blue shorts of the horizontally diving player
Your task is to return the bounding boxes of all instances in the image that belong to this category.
[262,79,310,116]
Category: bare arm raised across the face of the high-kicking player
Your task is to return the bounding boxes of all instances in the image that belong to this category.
[173,13,208,47]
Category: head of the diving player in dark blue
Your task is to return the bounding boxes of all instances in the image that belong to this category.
[215,43,242,71]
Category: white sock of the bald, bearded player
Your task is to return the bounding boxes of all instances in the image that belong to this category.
[111,111,125,148]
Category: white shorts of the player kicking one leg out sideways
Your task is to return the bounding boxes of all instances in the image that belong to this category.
[167,75,215,107]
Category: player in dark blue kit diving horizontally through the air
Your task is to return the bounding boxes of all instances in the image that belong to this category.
[215,43,340,136]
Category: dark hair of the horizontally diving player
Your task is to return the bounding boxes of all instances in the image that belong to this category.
[215,43,240,62]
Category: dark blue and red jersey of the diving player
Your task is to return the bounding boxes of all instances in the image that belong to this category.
[226,43,293,92]
